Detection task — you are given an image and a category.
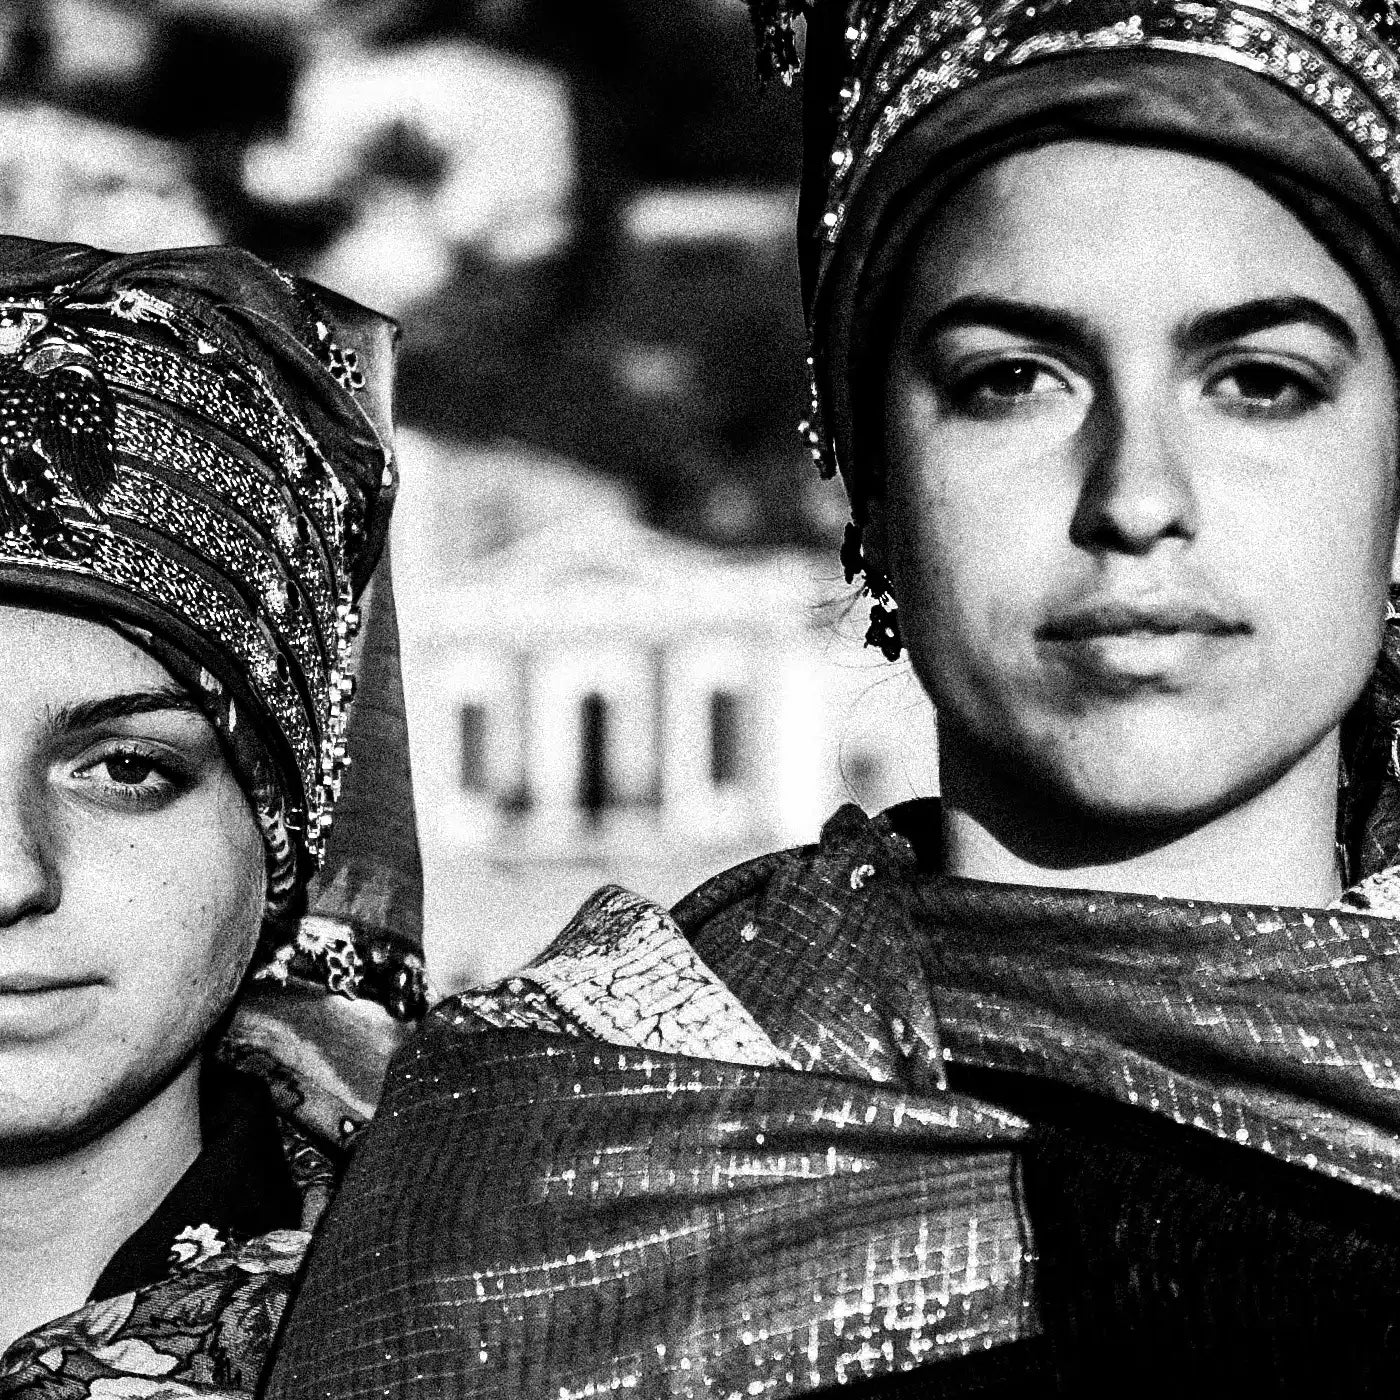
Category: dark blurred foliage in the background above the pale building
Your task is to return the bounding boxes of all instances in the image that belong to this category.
[10,0,832,545]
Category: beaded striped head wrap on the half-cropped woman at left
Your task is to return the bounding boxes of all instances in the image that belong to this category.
[0,238,421,1019]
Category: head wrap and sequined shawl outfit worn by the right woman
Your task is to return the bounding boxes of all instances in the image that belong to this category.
[272,0,1400,1400]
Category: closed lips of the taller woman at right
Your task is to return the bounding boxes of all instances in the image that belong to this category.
[1036,598,1250,694]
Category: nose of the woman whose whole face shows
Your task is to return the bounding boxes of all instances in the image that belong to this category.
[1070,391,1197,554]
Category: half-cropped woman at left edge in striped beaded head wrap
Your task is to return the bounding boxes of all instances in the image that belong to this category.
[0,239,423,1397]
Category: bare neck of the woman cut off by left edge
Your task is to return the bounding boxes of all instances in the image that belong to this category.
[0,1060,200,1352]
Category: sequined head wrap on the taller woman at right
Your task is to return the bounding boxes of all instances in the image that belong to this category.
[750,0,1400,515]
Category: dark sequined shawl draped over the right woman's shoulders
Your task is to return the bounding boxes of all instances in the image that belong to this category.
[270,808,1400,1400]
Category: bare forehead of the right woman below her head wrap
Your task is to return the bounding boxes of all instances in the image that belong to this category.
[910,141,1369,316]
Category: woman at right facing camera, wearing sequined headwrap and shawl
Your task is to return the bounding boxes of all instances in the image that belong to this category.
[277,0,1400,1397]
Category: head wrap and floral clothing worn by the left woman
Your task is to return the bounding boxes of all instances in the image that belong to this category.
[0,238,426,1400]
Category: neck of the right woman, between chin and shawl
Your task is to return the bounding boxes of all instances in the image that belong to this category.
[939,732,1341,909]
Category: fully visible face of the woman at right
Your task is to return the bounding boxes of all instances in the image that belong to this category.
[872,143,1396,829]
